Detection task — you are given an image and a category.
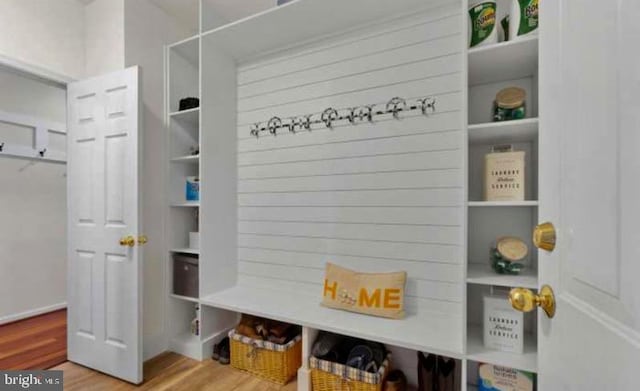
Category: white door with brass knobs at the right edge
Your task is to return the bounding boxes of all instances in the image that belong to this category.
[538,0,640,391]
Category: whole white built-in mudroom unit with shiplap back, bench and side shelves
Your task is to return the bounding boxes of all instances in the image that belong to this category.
[166,0,539,391]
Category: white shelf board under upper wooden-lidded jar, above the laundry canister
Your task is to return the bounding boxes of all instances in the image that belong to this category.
[468,118,539,144]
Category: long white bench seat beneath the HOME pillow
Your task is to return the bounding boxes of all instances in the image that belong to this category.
[200,285,463,358]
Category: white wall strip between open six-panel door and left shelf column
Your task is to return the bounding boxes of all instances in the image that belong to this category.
[124,0,190,359]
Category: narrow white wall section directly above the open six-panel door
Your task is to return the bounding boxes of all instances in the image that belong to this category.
[84,0,125,77]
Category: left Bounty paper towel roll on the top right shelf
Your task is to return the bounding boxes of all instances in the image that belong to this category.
[468,0,498,48]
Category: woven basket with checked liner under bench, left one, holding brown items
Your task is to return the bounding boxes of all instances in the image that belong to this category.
[229,330,302,384]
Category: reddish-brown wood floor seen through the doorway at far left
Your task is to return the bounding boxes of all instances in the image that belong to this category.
[0,310,67,370]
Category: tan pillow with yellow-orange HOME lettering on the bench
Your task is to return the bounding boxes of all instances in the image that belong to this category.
[322,262,407,319]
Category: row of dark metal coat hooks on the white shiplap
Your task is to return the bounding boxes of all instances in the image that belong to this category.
[250,96,436,138]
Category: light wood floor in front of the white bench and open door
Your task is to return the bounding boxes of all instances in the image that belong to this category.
[52,353,297,391]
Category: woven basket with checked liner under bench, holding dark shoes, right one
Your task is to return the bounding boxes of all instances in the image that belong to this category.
[309,354,391,391]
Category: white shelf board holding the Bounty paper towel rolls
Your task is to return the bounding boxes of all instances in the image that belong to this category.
[469,36,538,86]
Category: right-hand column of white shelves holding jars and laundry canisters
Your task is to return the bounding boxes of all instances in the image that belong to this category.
[465,1,539,390]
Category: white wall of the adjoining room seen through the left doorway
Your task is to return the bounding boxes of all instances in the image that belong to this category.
[0,68,67,323]
